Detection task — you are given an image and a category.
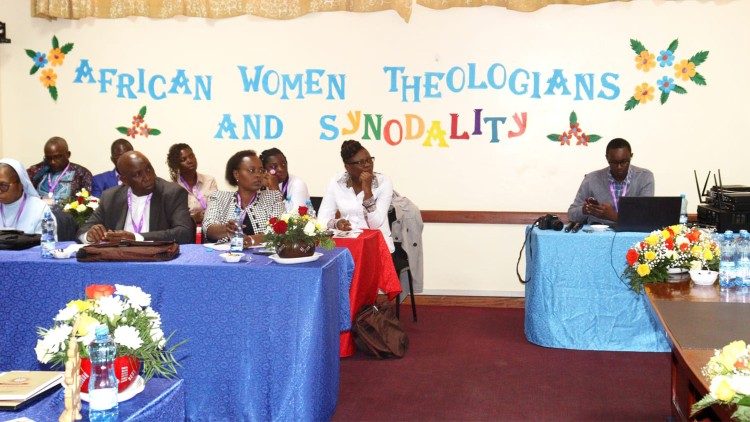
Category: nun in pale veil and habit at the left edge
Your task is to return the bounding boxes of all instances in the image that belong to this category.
[0,158,50,233]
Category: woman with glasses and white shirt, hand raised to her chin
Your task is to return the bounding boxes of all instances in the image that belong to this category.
[318,140,395,253]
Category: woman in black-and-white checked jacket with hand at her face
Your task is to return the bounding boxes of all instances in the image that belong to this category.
[203,150,284,247]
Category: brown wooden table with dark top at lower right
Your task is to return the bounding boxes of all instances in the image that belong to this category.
[646,281,750,420]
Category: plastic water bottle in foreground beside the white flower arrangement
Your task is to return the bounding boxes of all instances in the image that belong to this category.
[89,325,119,422]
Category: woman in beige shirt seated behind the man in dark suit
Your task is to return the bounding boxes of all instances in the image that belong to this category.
[167,143,219,224]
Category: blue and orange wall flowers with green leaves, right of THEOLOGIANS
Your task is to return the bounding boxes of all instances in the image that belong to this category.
[625,39,708,111]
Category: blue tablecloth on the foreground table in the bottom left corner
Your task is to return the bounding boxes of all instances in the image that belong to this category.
[0,378,185,422]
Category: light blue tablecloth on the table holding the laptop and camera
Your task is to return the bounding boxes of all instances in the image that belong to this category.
[524,228,670,352]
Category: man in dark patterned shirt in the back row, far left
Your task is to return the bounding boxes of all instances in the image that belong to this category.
[27,136,93,204]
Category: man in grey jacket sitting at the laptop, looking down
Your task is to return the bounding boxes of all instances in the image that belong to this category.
[568,138,654,224]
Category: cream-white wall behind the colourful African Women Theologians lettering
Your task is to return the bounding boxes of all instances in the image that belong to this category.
[0,0,750,295]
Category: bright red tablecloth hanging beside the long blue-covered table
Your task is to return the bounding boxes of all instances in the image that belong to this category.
[333,230,401,357]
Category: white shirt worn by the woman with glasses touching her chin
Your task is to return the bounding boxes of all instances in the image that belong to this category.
[318,173,396,253]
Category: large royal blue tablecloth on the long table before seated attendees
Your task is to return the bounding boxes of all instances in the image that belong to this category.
[0,245,354,420]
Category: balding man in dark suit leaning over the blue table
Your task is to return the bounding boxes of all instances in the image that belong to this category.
[78,151,195,243]
